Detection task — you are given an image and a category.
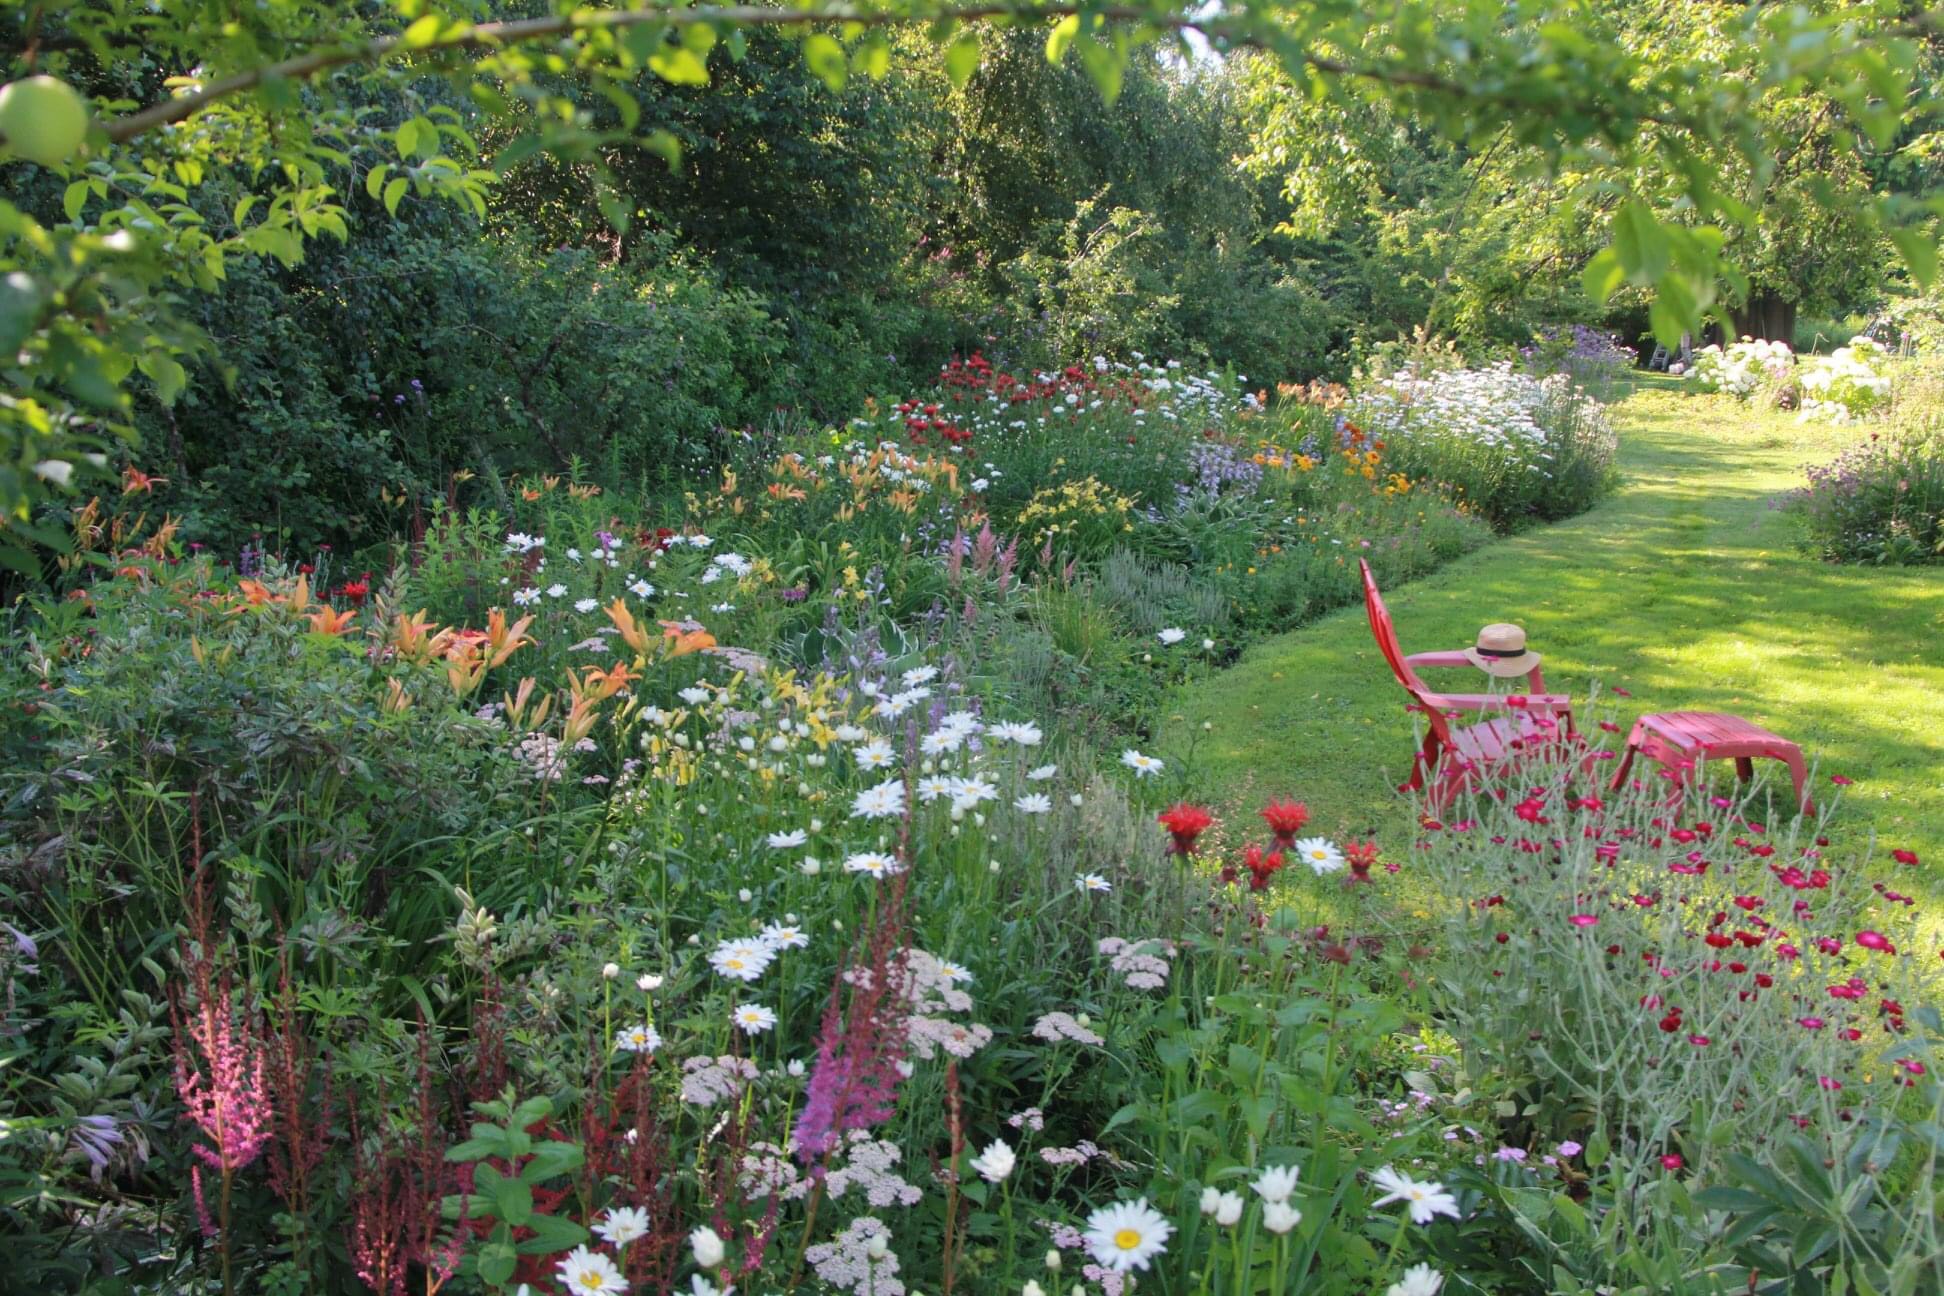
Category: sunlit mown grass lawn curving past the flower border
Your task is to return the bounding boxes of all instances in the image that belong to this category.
[1178,385,1944,878]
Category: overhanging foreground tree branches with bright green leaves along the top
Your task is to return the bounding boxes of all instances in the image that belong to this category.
[0,0,1938,563]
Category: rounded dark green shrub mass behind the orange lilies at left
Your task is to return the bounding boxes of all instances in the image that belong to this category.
[142,225,785,552]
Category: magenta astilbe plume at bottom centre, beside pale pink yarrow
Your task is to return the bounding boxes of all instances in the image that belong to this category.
[795,872,908,1164]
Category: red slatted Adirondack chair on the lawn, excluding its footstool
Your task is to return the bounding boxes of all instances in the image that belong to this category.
[1359,560,1575,810]
